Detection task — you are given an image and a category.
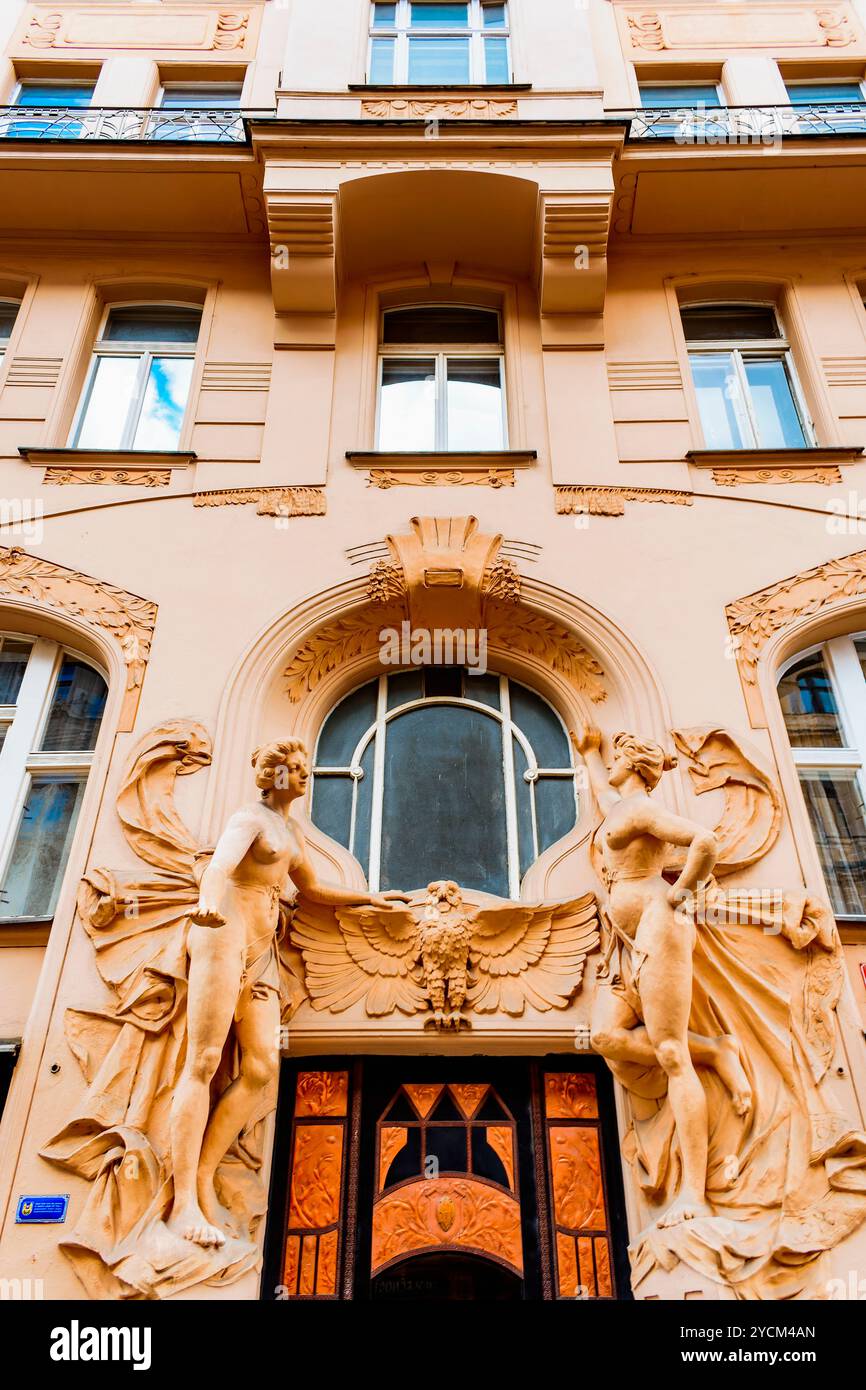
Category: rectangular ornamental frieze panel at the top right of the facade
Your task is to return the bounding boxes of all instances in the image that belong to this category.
[624,3,859,53]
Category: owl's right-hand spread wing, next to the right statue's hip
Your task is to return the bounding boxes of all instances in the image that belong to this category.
[466,892,599,1016]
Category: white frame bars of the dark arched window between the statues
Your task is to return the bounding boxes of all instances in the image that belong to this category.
[313,667,582,899]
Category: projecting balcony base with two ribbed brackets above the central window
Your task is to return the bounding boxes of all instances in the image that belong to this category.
[253,120,624,316]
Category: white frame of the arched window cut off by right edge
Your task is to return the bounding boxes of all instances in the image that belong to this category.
[776,631,866,922]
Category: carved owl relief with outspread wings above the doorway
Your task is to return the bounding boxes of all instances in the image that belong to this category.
[292,880,599,1029]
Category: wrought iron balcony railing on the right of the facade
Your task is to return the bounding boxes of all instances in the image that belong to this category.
[628,101,866,145]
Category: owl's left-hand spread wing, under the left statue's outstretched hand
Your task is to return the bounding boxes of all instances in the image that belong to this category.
[292,897,428,1017]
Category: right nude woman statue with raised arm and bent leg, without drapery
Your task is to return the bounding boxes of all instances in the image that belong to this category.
[571,727,752,1226]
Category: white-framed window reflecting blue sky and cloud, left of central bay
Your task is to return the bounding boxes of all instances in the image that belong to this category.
[71,304,202,450]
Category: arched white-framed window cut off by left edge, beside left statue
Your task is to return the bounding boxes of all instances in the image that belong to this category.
[0,632,107,920]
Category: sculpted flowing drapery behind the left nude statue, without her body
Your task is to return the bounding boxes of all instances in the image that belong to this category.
[42,721,311,1298]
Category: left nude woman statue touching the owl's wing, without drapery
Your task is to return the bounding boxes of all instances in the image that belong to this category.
[167,739,409,1247]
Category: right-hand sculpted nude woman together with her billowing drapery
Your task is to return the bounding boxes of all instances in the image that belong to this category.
[574,728,866,1298]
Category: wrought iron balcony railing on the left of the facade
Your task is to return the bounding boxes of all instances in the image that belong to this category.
[0,106,248,145]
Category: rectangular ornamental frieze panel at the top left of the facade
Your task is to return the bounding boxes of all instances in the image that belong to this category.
[21,4,252,53]
